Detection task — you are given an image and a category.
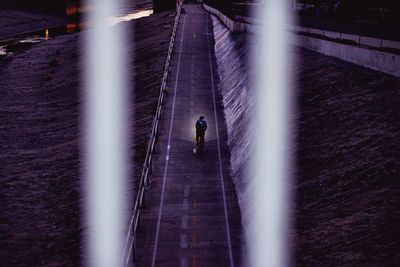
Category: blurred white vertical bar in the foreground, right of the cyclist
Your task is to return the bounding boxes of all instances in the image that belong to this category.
[250,0,293,267]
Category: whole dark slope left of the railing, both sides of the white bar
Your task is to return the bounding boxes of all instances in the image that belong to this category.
[0,9,174,266]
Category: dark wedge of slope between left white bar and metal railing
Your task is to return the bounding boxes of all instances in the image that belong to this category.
[130,12,175,191]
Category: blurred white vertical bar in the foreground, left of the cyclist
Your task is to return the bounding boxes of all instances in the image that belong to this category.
[82,0,130,267]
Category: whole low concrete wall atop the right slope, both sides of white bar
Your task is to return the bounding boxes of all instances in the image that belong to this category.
[203,3,400,77]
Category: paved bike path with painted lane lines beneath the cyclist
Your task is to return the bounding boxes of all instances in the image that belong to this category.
[136,5,242,266]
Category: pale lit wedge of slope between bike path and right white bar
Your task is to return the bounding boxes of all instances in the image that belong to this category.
[212,16,253,227]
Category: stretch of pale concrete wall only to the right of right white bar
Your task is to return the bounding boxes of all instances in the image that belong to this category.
[293,35,400,77]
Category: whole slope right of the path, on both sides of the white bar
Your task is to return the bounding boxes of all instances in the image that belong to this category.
[213,14,400,266]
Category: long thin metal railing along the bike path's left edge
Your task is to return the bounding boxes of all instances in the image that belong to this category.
[123,1,182,266]
